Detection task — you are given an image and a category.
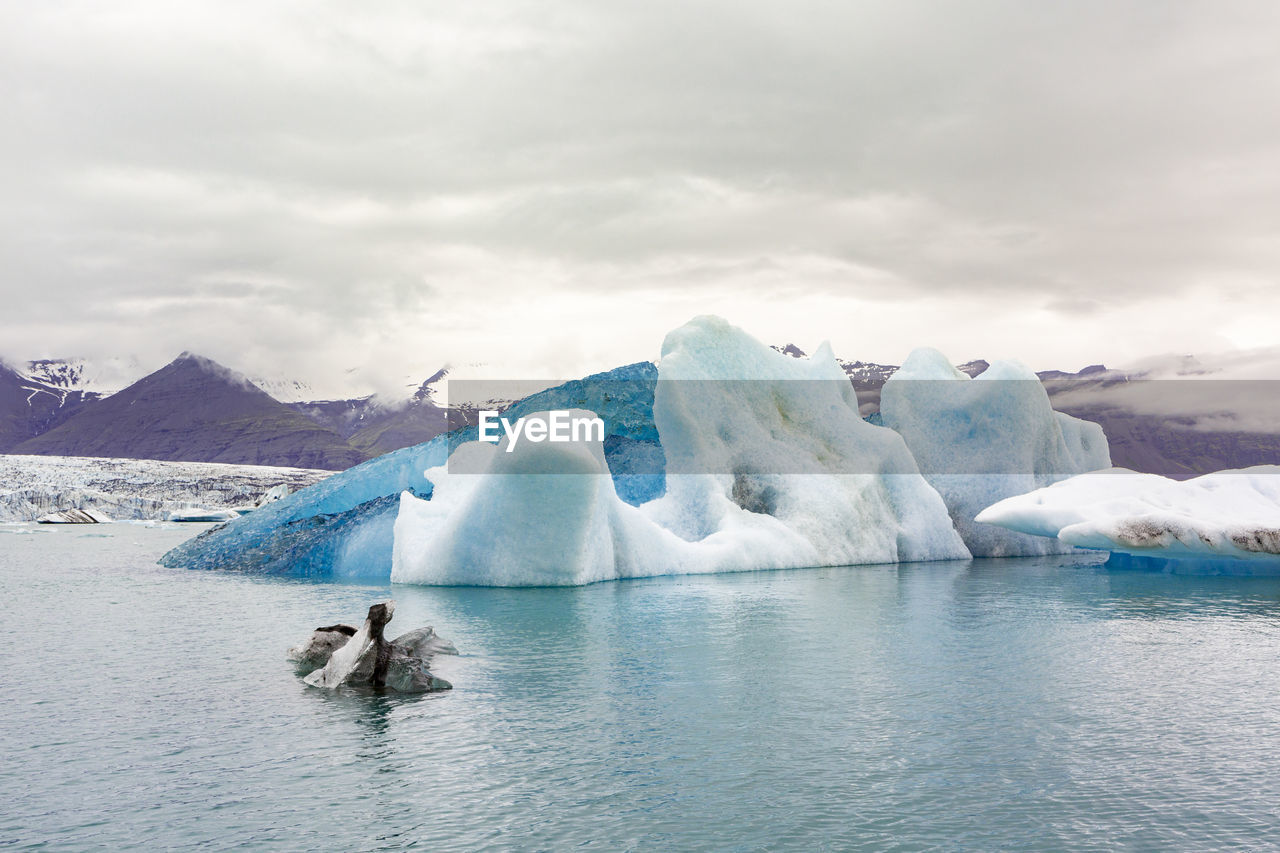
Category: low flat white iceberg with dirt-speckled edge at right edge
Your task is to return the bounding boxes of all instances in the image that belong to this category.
[978,465,1280,570]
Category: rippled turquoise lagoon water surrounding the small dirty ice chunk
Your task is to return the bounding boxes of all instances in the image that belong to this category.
[0,525,1280,850]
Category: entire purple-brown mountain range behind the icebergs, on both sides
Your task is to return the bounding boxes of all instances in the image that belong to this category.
[0,345,1280,479]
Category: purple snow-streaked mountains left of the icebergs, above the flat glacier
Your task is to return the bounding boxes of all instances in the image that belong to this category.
[0,352,460,470]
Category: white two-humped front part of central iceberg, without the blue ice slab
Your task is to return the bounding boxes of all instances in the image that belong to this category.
[392,318,969,585]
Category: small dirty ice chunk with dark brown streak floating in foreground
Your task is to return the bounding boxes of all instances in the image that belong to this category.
[288,601,458,693]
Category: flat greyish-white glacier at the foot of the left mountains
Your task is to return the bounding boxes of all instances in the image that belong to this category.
[0,455,333,521]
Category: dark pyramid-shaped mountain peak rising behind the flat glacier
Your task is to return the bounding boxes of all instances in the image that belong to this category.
[9,352,367,470]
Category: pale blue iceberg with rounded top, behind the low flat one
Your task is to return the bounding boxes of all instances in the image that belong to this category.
[879,348,1111,557]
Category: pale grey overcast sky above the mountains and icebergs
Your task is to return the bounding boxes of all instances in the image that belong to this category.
[0,0,1280,391]
